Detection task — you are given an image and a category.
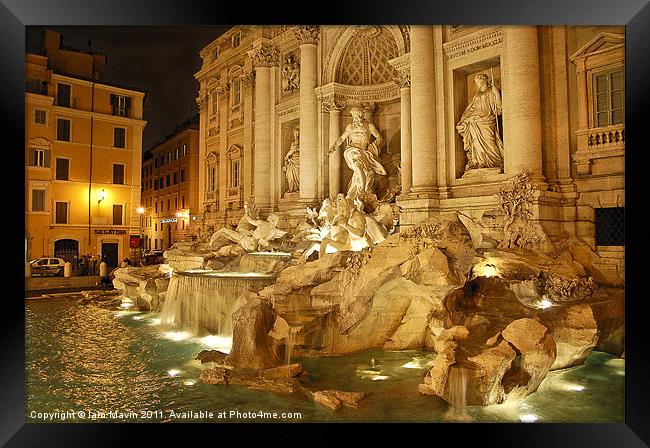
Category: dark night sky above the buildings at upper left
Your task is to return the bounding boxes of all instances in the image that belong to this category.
[25,26,231,155]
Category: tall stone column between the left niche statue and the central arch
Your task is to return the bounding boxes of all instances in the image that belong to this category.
[293,25,319,202]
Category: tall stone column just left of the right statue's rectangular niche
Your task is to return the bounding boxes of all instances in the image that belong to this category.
[410,25,437,193]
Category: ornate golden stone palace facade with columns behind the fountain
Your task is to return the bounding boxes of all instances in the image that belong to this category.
[195,25,625,269]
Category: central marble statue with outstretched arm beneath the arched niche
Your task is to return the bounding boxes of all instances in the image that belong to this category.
[328,107,386,199]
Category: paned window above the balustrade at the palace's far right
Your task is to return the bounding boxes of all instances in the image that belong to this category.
[593,68,625,128]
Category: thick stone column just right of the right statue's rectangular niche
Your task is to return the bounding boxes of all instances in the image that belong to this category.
[503,26,543,181]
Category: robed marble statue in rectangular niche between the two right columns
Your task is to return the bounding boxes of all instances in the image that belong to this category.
[456,73,503,173]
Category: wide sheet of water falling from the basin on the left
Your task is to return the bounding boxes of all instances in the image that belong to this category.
[160,271,272,337]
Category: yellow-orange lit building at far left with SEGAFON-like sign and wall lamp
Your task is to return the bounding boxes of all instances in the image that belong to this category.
[25,30,146,266]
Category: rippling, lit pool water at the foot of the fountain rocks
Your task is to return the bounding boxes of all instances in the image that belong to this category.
[26,299,625,423]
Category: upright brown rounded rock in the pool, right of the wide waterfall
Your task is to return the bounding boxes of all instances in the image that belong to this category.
[226,299,280,369]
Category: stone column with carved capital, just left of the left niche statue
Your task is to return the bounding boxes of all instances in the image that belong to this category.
[248,43,280,211]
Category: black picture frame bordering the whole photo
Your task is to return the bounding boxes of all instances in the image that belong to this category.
[0,0,650,447]
